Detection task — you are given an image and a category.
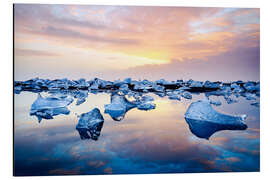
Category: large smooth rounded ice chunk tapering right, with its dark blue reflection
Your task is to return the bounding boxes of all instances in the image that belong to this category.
[185,100,247,139]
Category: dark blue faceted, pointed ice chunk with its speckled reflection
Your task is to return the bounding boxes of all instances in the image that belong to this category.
[76,108,104,141]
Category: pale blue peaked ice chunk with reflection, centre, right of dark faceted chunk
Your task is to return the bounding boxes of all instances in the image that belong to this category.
[104,93,136,121]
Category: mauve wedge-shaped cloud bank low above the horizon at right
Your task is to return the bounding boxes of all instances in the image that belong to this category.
[112,47,260,81]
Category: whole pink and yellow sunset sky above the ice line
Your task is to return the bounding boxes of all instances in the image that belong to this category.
[14,4,260,81]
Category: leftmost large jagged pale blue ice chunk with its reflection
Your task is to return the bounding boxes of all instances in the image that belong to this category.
[30,94,73,122]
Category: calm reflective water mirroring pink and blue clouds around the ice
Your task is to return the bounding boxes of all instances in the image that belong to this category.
[14,91,260,175]
